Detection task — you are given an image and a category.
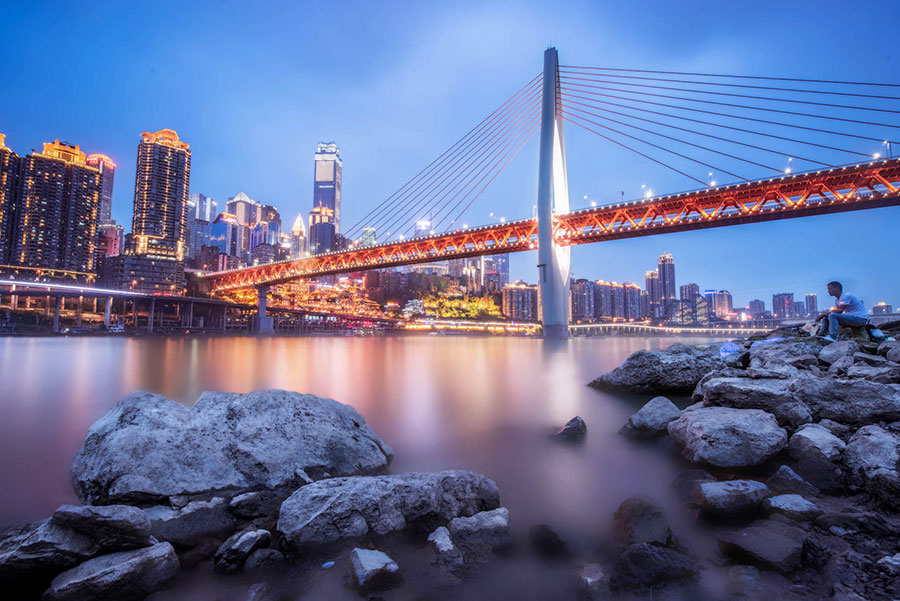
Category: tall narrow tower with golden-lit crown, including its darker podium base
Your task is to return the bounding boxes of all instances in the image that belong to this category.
[105,129,191,294]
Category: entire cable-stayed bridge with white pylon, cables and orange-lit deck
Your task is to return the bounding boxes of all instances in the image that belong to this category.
[203,48,900,336]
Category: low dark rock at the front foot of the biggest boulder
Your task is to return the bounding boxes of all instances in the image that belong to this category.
[144,497,237,547]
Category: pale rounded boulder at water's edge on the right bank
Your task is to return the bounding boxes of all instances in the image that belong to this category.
[669,407,788,467]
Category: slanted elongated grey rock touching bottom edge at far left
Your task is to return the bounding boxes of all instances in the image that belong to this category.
[43,543,178,601]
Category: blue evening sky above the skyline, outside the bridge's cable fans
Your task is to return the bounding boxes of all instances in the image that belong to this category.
[0,0,900,306]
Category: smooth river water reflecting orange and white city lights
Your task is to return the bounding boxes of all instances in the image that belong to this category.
[0,337,724,530]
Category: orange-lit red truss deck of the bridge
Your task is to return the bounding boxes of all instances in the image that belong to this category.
[201,159,900,293]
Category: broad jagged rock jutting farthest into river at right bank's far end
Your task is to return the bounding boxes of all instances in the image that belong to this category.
[590,344,722,393]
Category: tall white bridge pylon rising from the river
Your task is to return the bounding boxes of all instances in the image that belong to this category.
[537,48,570,338]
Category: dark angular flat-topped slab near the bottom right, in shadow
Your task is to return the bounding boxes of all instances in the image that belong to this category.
[716,520,806,574]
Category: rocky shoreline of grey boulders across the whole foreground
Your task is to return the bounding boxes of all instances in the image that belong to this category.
[0,324,900,601]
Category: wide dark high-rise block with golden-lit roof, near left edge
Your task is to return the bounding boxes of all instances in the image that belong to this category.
[12,140,100,273]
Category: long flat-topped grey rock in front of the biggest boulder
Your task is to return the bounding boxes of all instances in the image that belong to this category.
[278,470,500,551]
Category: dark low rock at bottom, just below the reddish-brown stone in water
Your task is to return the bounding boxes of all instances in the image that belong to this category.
[610,543,697,590]
